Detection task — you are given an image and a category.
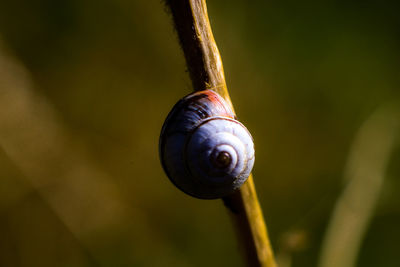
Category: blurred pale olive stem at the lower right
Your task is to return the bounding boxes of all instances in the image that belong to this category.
[318,105,400,267]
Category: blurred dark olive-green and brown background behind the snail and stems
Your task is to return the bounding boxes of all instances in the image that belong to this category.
[0,0,400,267]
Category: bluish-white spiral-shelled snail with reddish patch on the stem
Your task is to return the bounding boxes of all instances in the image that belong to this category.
[159,90,254,199]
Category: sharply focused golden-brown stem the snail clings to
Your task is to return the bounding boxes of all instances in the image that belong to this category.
[166,0,276,267]
